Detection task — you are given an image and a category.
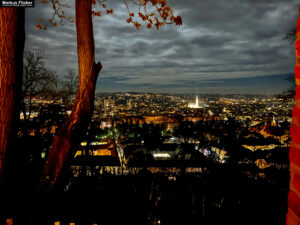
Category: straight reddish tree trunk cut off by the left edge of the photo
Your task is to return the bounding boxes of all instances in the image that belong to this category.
[0,8,25,181]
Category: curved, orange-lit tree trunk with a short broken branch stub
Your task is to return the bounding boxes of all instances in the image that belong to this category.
[42,0,102,188]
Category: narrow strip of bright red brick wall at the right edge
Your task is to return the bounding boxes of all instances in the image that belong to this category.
[286,7,300,225]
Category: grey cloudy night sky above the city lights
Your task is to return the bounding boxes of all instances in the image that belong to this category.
[26,0,299,94]
